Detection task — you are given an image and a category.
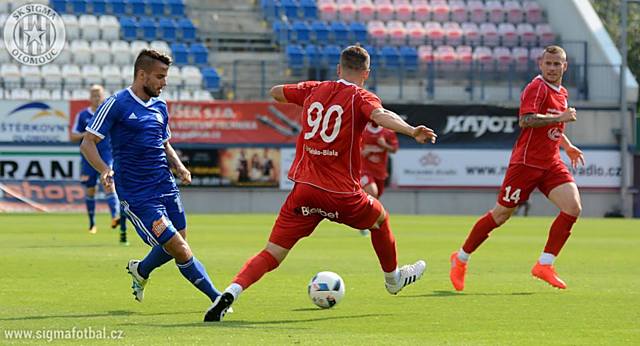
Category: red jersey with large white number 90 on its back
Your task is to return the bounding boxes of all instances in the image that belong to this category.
[283,79,382,193]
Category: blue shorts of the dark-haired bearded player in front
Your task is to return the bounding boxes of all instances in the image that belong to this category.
[120,193,187,246]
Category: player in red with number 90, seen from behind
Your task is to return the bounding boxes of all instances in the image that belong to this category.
[204,46,436,321]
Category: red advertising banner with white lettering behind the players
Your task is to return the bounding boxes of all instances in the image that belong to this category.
[69,101,301,144]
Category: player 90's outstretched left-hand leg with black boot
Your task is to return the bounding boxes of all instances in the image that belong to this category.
[204,184,322,322]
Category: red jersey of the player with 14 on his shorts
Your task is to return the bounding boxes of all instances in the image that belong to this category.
[509,75,569,169]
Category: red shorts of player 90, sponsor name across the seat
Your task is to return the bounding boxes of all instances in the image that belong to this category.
[269,183,384,249]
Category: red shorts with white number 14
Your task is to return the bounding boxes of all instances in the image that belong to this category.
[498,161,575,208]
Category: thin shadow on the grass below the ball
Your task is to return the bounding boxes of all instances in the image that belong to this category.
[136,309,392,329]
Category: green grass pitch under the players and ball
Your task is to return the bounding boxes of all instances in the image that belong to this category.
[0,214,640,345]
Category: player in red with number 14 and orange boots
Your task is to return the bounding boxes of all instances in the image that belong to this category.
[449,46,584,291]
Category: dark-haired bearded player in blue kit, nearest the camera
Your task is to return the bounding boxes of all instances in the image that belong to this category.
[80,49,220,301]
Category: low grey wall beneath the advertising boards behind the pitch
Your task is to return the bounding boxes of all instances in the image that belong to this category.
[182,188,619,217]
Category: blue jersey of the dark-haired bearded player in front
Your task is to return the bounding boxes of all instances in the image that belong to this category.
[86,88,178,204]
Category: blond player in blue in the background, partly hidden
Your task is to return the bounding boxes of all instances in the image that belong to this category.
[69,85,129,245]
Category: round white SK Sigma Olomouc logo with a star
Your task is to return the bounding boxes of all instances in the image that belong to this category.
[4,4,66,66]
